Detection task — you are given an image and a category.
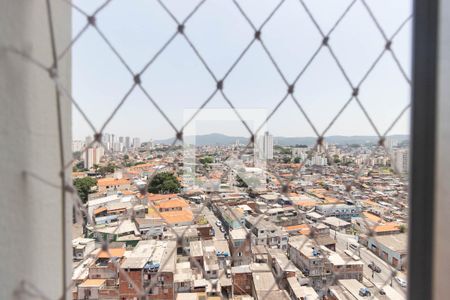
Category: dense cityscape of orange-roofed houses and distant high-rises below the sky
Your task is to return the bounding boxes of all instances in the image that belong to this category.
[72,132,409,300]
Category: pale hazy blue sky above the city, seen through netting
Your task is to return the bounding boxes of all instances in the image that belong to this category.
[72,0,412,141]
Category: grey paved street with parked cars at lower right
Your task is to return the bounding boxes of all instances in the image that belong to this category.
[331,231,406,299]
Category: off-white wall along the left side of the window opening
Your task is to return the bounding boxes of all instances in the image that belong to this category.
[0,0,72,299]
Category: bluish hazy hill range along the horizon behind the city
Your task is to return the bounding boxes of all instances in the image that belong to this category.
[155,133,409,146]
